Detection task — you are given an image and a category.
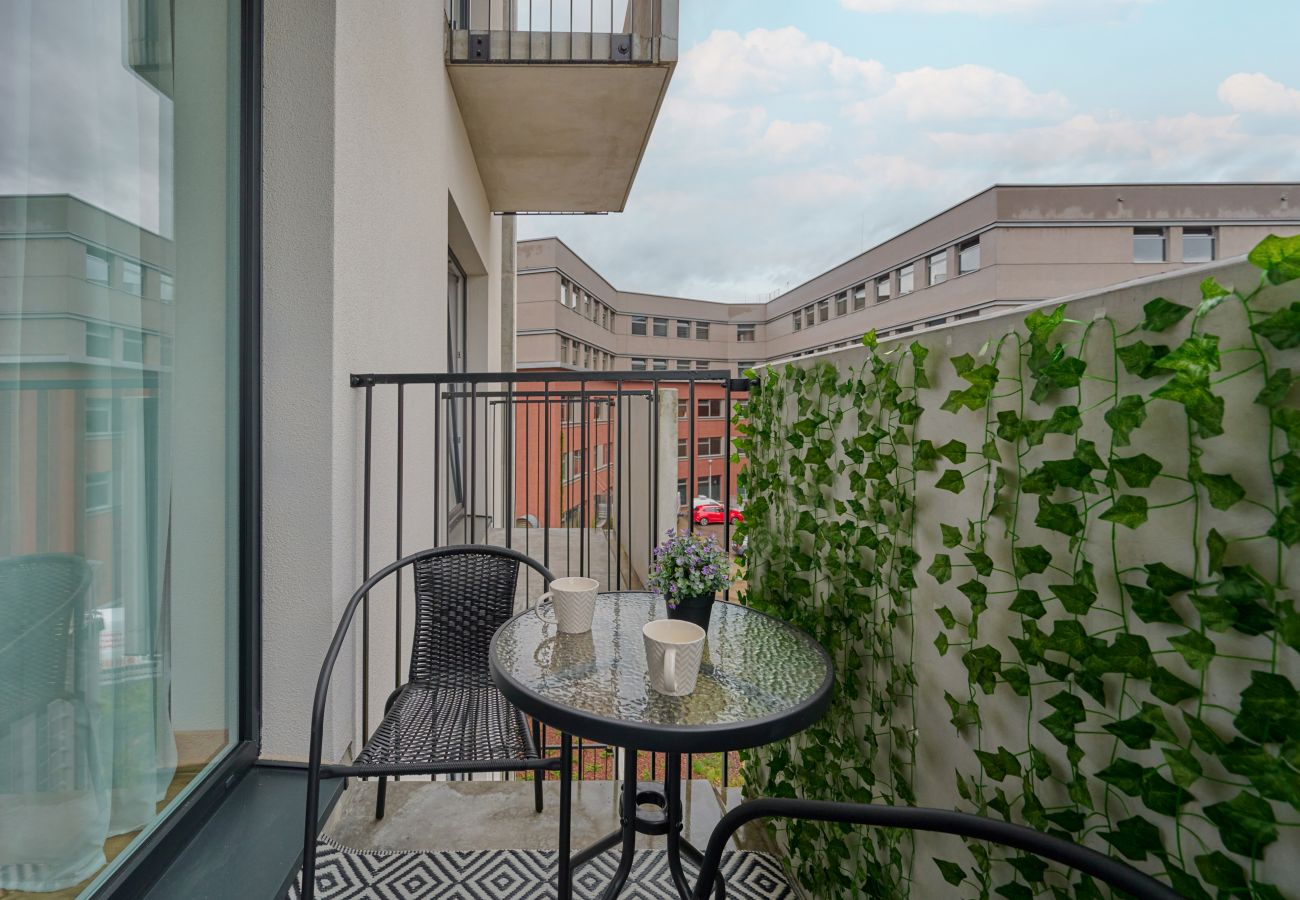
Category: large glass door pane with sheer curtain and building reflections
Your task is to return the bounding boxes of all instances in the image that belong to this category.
[0,0,246,896]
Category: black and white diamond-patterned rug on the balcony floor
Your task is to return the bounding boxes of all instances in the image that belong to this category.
[287,841,796,900]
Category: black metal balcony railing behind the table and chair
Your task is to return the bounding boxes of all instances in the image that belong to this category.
[351,371,749,791]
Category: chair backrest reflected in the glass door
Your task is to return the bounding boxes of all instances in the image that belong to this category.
[0,553,91,723]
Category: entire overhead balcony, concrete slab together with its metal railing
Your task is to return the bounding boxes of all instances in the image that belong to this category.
[447,0,677,212]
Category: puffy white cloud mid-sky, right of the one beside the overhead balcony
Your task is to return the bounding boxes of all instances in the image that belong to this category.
[848,65,1070,124]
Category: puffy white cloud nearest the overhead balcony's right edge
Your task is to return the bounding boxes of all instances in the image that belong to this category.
[677,26,884,98]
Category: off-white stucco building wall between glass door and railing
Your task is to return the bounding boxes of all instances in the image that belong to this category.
[263,0,503,758]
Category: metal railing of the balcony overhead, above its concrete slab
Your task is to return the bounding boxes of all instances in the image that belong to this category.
[446,0,676,64]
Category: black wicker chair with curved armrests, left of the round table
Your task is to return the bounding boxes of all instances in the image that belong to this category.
[302,545,568,900]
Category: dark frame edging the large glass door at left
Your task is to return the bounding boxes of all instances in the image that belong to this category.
[86,0,263,900]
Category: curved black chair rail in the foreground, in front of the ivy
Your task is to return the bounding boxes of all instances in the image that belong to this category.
[693,797,1182,900]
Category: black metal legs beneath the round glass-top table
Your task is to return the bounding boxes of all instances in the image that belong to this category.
[569,749,727,900]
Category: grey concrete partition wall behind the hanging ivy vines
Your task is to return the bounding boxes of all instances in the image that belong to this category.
[751,260,1300,897]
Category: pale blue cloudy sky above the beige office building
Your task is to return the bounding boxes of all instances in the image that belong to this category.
[519,0,1300,302]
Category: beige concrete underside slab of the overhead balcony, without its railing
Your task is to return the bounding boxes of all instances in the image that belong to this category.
[447,62,672,212]
